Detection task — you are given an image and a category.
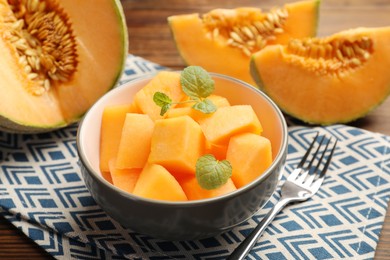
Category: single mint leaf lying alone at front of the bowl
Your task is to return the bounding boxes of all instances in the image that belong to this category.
[195,154,232,190]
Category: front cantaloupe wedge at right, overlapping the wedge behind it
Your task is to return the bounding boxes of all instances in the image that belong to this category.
[251,27,390,125]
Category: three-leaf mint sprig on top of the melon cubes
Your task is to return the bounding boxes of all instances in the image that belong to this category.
[153,66,217,116]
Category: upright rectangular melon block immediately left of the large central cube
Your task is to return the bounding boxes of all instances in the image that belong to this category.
[116,113,154,169]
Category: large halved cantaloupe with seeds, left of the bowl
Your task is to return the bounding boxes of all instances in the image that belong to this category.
[0,0,128,132]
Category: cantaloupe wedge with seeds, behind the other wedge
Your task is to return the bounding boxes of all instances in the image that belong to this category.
[168,0,320,85]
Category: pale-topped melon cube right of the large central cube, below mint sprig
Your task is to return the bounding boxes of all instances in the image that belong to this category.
[199,105,263,144]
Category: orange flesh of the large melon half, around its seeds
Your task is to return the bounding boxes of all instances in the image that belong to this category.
[0,0,128,132]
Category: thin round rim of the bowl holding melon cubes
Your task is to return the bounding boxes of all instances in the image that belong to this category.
[76,71,288,207]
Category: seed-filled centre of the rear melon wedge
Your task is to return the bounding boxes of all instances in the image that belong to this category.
[203,8,288,56]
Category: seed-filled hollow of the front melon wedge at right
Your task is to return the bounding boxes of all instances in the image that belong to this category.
[286,36,374,75]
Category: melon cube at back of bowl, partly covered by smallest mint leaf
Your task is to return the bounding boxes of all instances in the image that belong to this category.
[134,71,185,120]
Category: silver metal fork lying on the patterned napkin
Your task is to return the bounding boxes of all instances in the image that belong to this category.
[227,133,337,260]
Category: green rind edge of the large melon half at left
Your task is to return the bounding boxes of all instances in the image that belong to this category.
[0,0,129,134]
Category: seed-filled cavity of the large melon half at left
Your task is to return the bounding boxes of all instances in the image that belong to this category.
[0,0,78,96]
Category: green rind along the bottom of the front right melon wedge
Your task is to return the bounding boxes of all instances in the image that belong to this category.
[250,55,390,126]
